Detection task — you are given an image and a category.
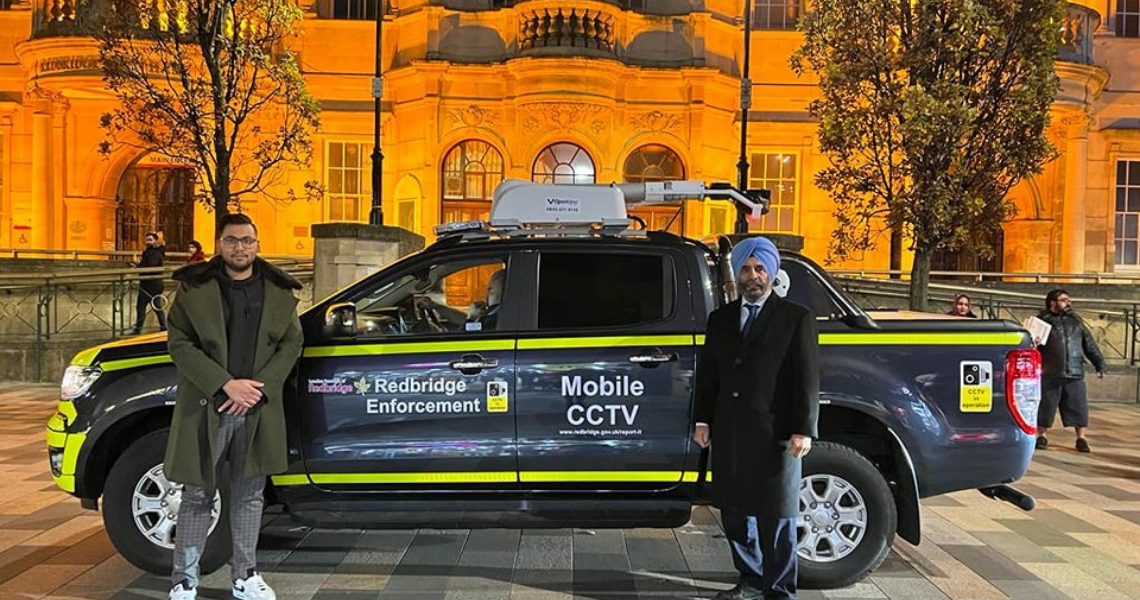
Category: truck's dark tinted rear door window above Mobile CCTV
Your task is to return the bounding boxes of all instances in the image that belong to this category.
[538,252,676,330]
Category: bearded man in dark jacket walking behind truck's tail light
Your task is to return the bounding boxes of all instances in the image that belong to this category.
[1037,289,1106,452]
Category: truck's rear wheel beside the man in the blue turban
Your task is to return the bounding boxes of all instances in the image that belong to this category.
[797,441,898,590]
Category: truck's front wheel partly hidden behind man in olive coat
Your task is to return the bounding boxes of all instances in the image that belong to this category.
[103,429,234,575]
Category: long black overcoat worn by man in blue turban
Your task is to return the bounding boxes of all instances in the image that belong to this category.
[694,294,820,519]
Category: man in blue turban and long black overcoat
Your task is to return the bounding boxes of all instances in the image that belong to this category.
[693,237,820,600]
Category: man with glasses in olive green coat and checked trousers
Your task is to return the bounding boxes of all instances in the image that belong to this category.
[163,214,302,600]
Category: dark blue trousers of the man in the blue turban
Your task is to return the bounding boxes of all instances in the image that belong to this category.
[720,510,798,600]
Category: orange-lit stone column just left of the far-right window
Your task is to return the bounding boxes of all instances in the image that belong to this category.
[1060,114,1089,273]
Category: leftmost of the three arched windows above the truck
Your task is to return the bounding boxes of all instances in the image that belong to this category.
[440,139,503,222]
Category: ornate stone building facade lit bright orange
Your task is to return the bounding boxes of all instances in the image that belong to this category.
[0,0,1140,273]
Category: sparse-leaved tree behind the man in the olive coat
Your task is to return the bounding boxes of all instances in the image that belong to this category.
[95,0,320,234]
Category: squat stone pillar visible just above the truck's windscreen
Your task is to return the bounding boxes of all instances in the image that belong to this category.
[312,222,424,301]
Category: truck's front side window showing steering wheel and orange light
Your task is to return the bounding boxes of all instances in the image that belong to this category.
[356,258,506,337]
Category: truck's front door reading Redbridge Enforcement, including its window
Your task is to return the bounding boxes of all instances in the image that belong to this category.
[298,253,518,492]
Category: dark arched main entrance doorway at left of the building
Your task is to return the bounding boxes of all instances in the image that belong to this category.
[115,163,195,252]
